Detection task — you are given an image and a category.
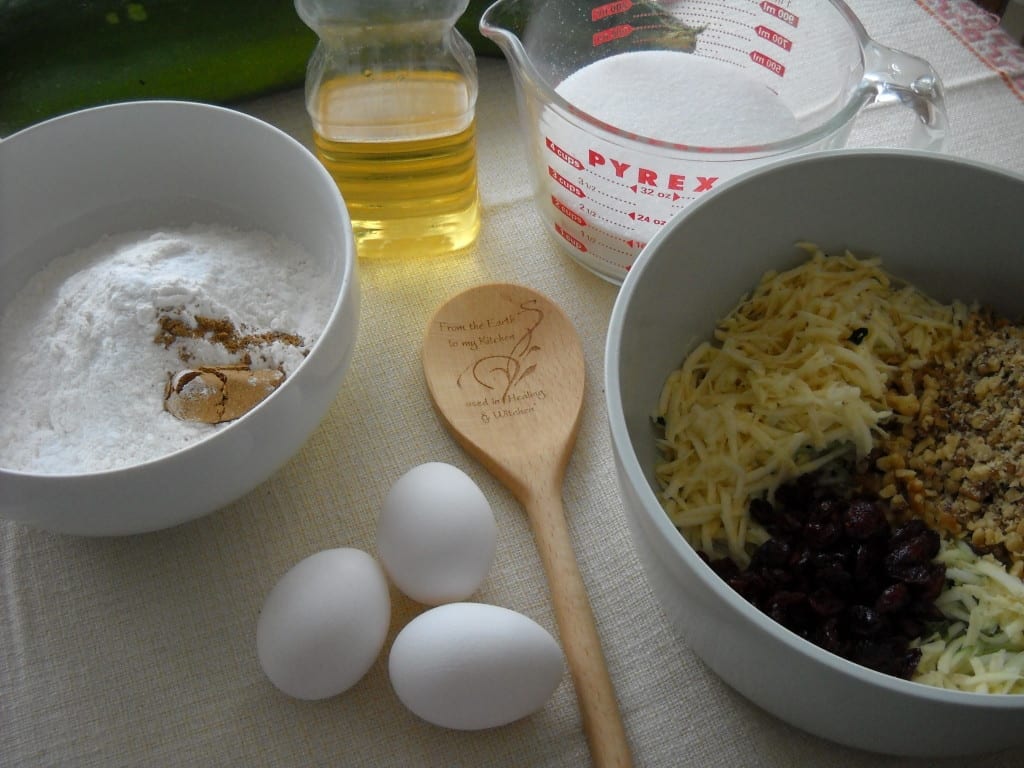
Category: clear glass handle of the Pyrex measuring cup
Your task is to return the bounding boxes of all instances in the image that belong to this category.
[862,41,949,152]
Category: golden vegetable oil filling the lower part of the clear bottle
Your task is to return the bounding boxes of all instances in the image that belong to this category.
[313,71,480,256]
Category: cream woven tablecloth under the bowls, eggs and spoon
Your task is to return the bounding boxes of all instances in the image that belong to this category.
[0,0,1024,767]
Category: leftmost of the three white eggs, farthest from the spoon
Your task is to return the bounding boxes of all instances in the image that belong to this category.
[256,548,391,699]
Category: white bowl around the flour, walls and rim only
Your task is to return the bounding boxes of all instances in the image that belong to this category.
[0,101,358,536]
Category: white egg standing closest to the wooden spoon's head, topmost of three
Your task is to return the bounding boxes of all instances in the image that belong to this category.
[377,462,498,605]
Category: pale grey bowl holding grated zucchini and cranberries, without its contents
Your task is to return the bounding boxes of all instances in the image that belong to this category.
[605,151,1024,756]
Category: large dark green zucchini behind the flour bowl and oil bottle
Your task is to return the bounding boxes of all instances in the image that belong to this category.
[0,0,499,136]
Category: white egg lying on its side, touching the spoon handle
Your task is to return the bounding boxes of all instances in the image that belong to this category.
[388,603,564,730]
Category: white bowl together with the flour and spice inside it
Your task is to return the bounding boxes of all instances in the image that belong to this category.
[0,101,358,536]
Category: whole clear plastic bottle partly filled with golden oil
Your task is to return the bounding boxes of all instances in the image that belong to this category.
[295,0,480,257]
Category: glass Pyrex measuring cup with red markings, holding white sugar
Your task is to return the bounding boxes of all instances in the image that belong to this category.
[480,0,946,283]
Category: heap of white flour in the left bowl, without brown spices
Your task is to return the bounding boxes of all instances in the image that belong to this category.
[0,225,333,474]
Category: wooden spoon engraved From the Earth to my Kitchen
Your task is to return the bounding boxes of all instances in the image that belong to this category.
[423,285,631,766]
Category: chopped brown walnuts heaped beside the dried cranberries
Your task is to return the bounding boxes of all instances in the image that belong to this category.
[869,312,1024,577]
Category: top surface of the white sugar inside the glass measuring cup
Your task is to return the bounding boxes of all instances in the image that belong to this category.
[555,50,799,146]
